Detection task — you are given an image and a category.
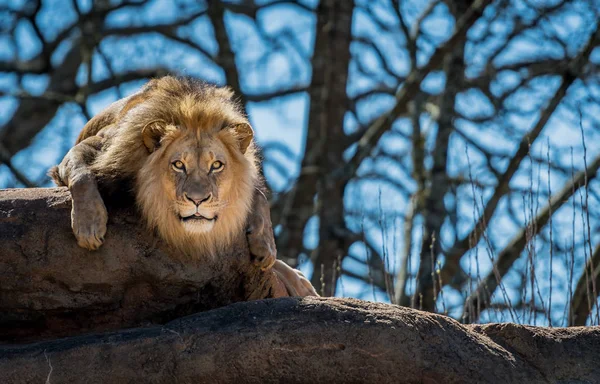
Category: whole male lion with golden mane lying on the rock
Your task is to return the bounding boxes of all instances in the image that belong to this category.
[49,76,317,296]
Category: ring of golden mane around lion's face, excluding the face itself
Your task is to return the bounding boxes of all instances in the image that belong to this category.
[135,124,258,254]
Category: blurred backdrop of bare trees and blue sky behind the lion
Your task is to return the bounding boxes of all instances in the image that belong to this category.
[0,0,600,326]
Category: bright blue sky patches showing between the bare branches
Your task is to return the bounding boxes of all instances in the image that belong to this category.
[0,0,600,321]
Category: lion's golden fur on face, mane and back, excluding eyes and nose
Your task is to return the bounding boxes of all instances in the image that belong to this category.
[51,76,259,255]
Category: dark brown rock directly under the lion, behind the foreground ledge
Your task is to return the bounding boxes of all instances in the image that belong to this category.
[0,188,287,340]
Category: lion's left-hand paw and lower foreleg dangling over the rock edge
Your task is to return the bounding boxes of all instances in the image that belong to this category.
[71,193,108,251]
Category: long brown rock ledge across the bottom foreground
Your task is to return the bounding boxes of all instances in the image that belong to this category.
[0,297,600,384]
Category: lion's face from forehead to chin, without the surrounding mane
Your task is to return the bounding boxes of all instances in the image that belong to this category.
[164,135,235,234]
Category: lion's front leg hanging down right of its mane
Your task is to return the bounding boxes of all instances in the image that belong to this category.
[246,188,277,270]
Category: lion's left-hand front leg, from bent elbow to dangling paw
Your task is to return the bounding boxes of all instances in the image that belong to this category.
[50,136,108,251]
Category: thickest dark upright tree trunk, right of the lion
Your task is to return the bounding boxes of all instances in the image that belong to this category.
[308,0,354,296]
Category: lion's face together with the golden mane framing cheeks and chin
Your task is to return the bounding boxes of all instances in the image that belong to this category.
[137,124,258,253]
